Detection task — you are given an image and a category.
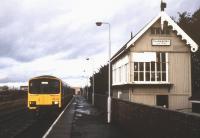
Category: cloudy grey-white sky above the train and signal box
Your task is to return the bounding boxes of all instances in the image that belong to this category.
[0,0,200,86]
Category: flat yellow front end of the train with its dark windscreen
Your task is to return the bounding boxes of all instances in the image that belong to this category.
[28,77,62,109]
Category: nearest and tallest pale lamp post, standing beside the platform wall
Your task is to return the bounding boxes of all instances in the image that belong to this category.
[96,22,111,123]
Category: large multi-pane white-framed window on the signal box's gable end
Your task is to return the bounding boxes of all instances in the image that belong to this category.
[132,52,168,82]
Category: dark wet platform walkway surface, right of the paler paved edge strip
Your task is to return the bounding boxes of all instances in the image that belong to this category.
[71,96,129,138]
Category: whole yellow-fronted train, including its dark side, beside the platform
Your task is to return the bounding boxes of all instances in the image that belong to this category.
[27,75,75,110]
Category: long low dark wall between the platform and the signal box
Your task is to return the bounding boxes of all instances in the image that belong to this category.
[95,95,200,138]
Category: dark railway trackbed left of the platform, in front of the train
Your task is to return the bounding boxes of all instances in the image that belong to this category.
[0,94,73,138]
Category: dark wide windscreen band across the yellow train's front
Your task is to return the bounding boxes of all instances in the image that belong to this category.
[29,79,60,94]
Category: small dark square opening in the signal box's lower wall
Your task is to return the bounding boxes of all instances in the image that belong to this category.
[156,95,168,108]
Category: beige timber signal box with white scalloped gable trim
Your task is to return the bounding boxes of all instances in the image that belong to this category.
[111,8,198,110]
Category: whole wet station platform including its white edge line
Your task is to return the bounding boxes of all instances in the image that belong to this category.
[43,96,129,138]
